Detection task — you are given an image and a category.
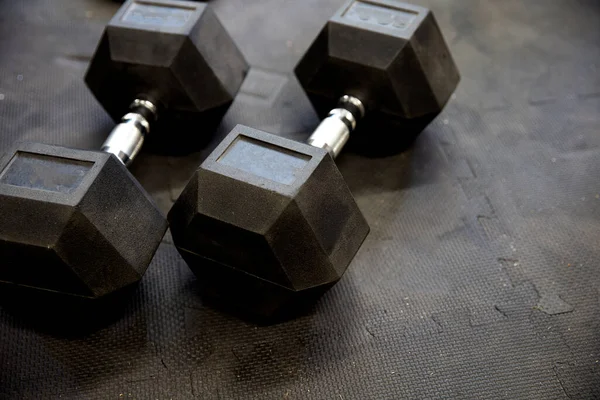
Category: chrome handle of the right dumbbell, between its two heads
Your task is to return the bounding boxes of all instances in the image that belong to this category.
[307,95,365,158]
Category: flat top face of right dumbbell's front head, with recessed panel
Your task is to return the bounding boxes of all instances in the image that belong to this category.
[202,125,328,195]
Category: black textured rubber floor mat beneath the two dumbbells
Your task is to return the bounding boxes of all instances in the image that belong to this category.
[0,0,600,400]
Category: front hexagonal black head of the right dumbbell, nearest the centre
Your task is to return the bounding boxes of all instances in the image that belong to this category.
[169,125,369,316]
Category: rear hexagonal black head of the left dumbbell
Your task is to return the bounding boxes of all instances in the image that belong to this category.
[85,0,248,151]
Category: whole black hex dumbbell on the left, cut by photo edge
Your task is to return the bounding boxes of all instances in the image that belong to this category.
[0,0,248,300]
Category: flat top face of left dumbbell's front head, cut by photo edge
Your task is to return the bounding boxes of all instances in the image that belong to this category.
[0,143,110,205]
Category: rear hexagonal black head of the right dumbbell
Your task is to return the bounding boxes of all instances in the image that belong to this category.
[295,0,460,152]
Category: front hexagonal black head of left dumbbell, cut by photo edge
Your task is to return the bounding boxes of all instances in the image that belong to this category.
[0,144,167,299]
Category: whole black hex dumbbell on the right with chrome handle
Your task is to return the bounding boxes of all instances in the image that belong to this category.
[168,0,460,317]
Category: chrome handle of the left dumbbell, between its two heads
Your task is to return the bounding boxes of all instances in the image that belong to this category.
[102,99,157,166]
